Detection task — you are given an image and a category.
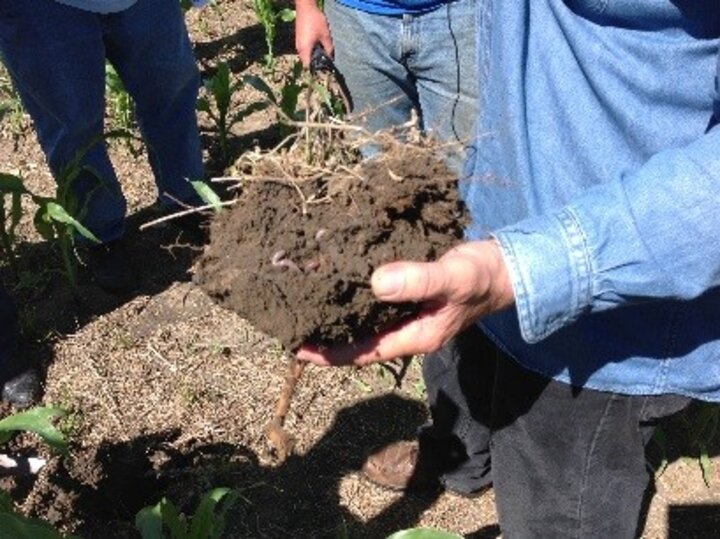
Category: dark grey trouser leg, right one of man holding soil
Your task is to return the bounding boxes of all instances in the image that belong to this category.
[490,356,689,538]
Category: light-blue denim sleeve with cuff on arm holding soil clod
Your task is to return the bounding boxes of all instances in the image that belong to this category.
[494,53,720,343]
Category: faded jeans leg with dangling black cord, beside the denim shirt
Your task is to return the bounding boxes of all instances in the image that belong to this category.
[407,0,479,171]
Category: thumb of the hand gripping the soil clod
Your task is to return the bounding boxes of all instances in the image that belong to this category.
[371,262,446,303]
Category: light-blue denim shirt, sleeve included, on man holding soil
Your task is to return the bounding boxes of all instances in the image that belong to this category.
[462,0,720,401]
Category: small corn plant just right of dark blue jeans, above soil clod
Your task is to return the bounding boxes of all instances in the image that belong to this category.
[197,62,267,163]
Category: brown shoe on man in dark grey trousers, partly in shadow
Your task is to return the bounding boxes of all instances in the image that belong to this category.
[362,440,440,490]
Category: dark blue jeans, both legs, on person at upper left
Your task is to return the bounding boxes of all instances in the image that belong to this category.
[0,0,204,241]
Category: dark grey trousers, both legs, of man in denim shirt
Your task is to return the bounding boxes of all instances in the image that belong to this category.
[420,326,690,539]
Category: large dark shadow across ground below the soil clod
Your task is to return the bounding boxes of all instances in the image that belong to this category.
[12,394,444,539]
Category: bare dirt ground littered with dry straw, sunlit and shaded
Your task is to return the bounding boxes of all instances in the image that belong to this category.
[0,0,720,538]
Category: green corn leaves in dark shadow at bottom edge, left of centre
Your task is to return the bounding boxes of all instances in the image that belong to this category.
[135,488,237,539]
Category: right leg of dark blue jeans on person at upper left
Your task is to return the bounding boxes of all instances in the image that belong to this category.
[104,0,204,206]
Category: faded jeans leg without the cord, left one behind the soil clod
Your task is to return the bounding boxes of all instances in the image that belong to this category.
[325,0,420,143]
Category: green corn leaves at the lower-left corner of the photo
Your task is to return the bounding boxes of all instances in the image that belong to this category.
[0,407,78,539]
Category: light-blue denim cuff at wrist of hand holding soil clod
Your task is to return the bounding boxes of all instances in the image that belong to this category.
[493,208,592,343]
